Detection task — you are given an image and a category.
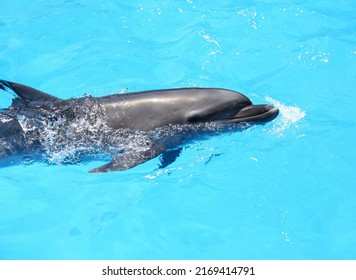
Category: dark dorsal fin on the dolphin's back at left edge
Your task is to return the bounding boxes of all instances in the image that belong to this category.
[0,80,61,102]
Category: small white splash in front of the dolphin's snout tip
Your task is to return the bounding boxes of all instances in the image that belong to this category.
[265,97,305,137]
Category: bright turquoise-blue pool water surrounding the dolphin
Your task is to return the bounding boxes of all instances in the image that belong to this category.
[0,0,356,259]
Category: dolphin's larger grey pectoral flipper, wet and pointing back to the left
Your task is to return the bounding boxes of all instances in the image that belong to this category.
[89,145,166,173]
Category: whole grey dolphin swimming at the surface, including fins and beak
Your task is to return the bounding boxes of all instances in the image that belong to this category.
[0,80,279,173]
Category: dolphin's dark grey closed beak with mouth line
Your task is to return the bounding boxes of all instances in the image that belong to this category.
[222,105,279,123]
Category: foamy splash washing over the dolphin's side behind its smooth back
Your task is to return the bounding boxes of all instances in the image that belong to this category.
[39,97,157,164]
